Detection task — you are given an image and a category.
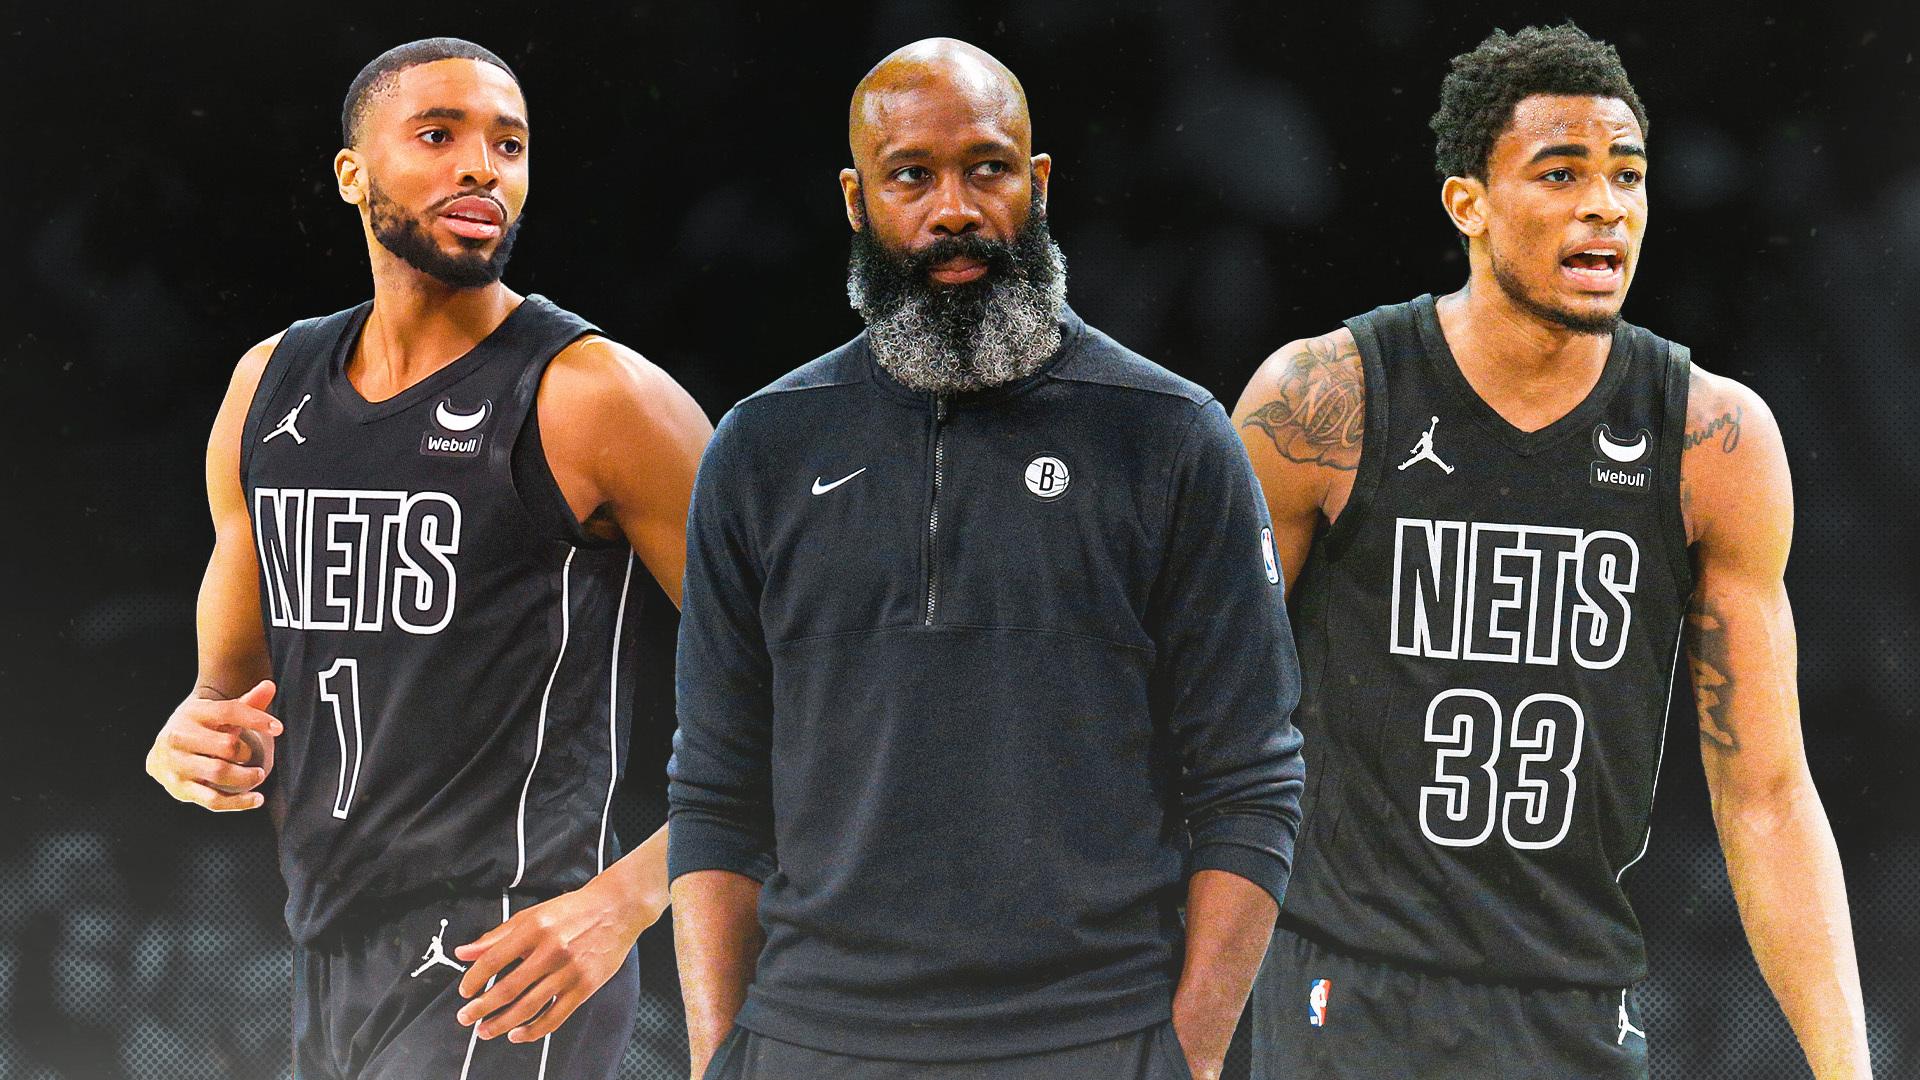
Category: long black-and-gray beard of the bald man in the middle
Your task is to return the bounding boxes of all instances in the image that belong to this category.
[847,194,1068,394]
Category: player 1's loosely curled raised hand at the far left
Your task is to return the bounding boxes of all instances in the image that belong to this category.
[146,678,284,811]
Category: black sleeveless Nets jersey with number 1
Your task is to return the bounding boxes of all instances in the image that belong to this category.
[240,296,634,942]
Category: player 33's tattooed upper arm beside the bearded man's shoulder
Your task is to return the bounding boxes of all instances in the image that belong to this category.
[1233,327,1367,588]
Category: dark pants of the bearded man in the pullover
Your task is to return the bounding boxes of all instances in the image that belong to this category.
[705,1020,1192,1080]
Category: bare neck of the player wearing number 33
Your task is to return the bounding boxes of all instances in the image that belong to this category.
[1436,273,1613,430]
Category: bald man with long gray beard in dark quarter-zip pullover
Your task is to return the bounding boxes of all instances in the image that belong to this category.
[668,40,1304,1080]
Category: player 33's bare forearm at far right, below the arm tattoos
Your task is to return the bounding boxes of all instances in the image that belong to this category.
[1713,774,1870,1080]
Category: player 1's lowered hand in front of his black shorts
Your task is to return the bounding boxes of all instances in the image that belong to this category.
[453,876,664,1043]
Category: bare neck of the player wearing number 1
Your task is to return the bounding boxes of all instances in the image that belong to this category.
[348,244,520,402]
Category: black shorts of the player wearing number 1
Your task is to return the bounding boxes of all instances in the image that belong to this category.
[294,896,639,1080]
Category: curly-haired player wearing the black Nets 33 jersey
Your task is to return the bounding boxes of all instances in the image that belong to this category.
[1235,23,1868,1078]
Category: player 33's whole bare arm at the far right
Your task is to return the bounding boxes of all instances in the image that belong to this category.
[1682,371,1870,1078]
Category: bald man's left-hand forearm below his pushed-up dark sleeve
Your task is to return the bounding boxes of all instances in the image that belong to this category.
[672,871,764,1076]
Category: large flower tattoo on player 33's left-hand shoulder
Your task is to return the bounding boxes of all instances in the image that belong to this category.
[1240,340,1367,471]
